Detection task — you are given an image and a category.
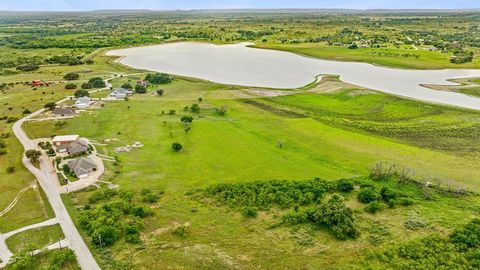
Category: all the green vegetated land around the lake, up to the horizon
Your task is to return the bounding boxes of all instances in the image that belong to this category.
[0,9,480,269]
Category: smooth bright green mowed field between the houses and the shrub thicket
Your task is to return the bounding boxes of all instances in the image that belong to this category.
[26,89,480,190]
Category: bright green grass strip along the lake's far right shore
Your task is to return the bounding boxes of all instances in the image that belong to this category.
[254,43,480,69]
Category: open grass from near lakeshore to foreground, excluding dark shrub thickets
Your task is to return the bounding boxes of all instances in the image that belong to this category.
[20,71,480,269]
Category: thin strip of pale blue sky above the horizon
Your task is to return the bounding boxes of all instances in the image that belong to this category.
[0,0,480,11]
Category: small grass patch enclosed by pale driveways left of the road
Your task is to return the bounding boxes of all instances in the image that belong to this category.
[6,224,63,254]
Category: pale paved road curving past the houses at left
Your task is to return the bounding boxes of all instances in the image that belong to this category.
[12,101,100,270]
